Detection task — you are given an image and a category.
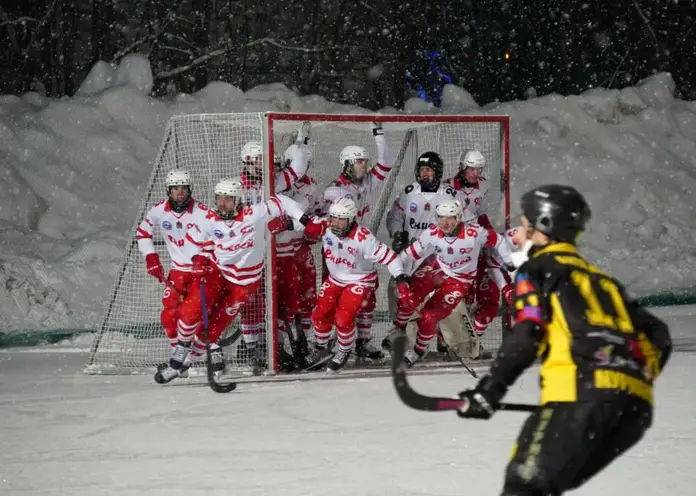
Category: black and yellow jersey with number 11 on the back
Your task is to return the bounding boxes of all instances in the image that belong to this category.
[491,243,671,404]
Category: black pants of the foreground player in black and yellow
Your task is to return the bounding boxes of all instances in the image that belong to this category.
[502,394,652,496]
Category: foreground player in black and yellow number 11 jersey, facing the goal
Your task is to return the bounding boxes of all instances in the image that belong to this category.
[459,185,672,496]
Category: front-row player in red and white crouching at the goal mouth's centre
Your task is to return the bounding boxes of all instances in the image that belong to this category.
[305,198,412,371]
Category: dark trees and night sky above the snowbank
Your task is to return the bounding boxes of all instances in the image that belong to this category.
[0,0,696,109]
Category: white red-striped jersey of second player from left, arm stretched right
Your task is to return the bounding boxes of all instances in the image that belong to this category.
[186,195,303,286]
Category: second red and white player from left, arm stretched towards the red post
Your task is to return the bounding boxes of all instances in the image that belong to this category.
[155,179,307,384]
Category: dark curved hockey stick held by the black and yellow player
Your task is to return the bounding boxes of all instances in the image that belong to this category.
[392,336,538,412]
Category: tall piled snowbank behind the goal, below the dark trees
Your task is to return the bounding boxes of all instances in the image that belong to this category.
[0,56,696,331]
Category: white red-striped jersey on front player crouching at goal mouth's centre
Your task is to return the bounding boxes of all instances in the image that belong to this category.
[305,218,404,287]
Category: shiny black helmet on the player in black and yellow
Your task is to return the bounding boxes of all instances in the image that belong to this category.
[521,184,592,243]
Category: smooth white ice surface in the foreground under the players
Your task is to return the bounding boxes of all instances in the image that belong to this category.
[0,307,696,496]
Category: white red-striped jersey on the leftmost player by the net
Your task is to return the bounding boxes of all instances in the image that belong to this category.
[135,199,209,272]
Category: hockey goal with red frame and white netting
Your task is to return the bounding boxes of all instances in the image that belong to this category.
[86,113,509,374]
